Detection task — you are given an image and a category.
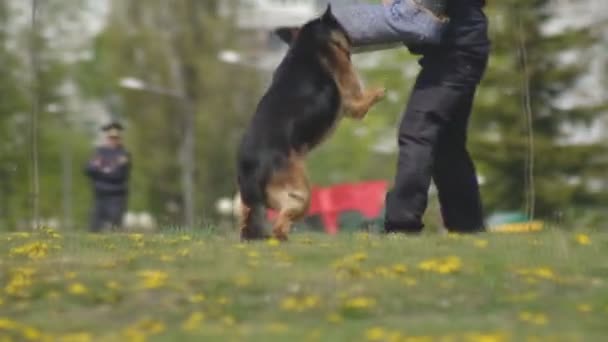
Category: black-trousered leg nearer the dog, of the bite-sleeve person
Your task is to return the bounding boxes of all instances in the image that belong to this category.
[385,78,458,233]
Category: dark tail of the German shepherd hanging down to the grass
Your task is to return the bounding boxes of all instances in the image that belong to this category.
[238,164,270,240]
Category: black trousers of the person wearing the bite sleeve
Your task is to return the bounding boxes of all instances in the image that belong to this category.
[385,61,485,233]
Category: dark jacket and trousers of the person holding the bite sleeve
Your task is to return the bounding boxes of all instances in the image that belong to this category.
[385,0,490,232]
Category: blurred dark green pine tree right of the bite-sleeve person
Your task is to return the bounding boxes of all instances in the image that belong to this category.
[469,0,607,218]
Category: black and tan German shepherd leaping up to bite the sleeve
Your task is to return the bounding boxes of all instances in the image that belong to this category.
[237,6,384,240]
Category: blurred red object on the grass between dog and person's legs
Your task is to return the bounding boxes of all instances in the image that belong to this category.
[269,181,388,235]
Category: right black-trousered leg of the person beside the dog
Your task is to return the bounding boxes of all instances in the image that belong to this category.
[433,88,484,233]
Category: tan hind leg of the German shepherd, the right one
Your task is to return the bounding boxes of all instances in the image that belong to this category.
[267,154,311,241]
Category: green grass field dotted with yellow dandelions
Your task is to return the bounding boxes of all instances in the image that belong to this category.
[0,230,608,342]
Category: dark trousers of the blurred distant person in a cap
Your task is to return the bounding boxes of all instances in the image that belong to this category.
[91,194,127,233]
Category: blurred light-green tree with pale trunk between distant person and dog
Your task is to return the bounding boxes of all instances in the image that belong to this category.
[81,0,258,225]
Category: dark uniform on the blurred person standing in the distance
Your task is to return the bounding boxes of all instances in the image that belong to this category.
[85,125,131,232]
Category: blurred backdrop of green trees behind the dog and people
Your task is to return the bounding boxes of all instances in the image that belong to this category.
[0,0,608,231]
